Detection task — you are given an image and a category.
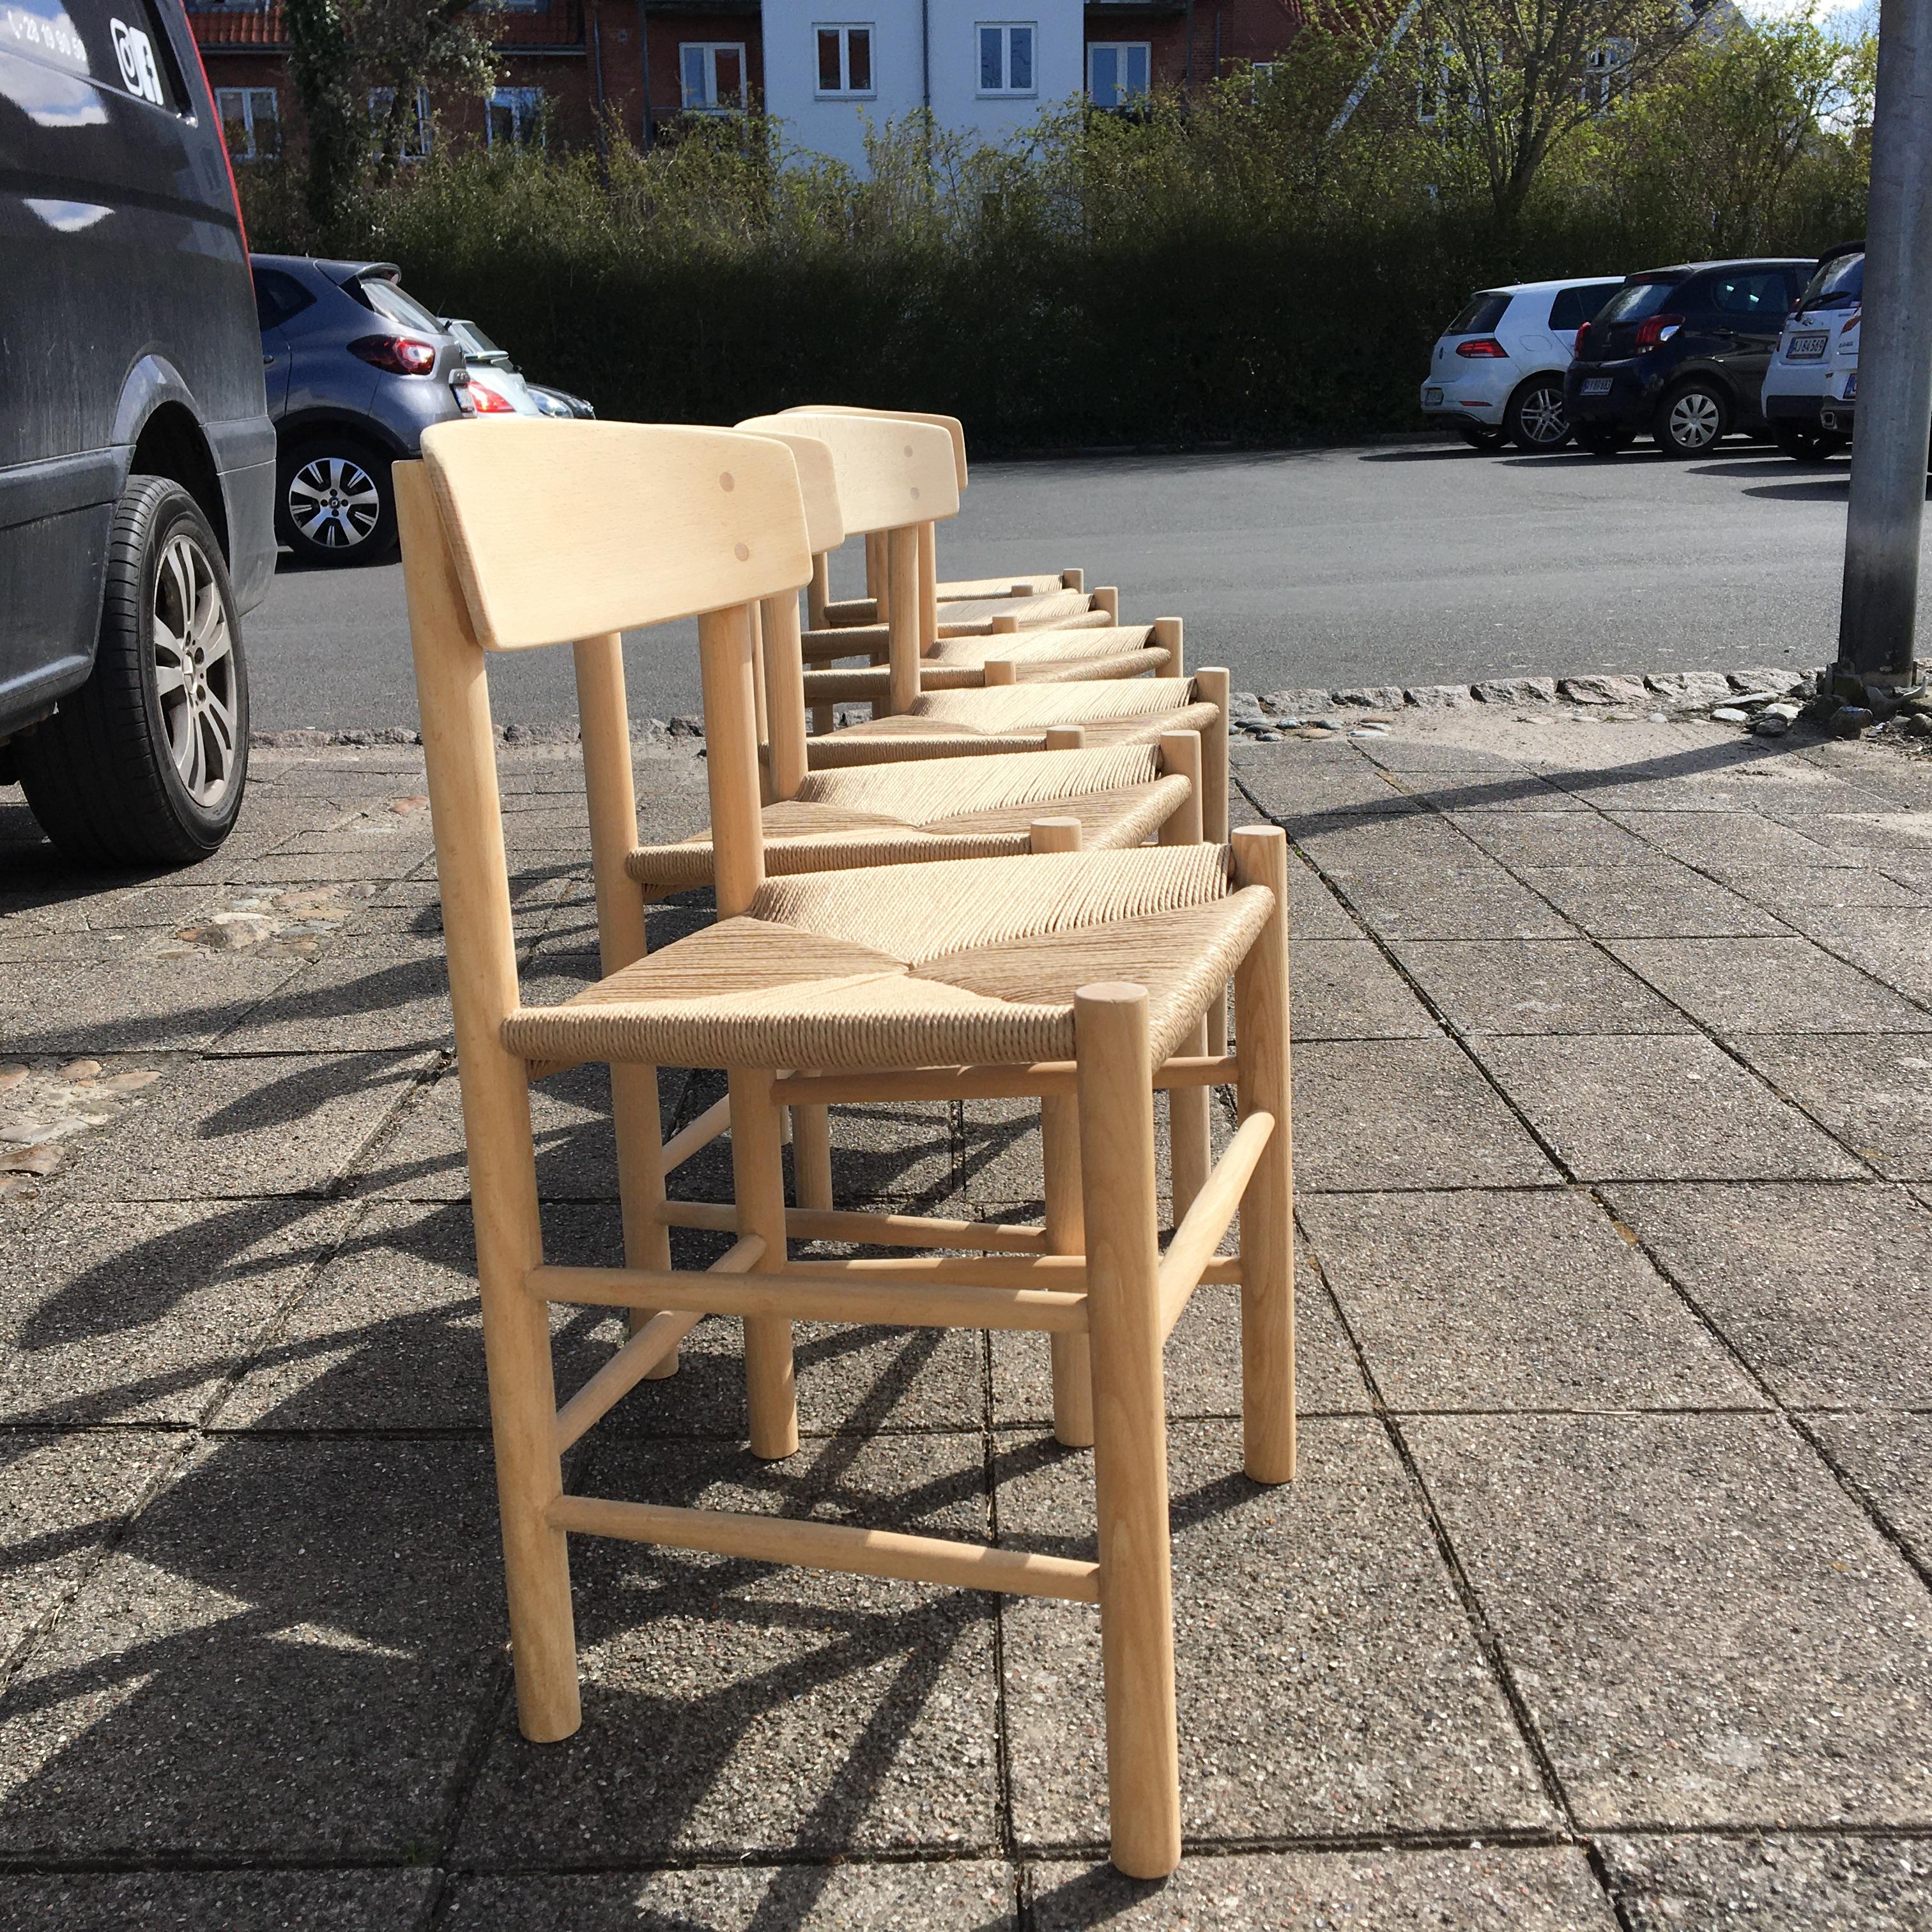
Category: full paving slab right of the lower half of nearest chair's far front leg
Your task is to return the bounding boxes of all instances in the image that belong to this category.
[1302,1188,1764,1411]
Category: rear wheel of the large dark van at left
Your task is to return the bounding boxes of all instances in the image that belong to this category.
[15,477,247,866]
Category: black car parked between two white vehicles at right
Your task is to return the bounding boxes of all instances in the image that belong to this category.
[1563,259,1813,456]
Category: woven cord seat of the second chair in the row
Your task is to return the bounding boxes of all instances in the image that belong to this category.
[624,744,1198,893]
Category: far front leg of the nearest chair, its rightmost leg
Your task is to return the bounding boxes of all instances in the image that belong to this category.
[1232,825,1294,1482]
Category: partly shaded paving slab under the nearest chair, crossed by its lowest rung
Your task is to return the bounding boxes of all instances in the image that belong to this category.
[452,1434,997,1868]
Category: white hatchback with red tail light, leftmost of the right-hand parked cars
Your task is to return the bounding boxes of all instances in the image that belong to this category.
[1422,274,1623,450]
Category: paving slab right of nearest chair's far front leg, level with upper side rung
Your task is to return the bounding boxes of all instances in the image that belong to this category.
[1294,1039,1557,1192]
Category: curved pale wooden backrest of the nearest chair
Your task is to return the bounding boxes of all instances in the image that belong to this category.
[423,417,811,651]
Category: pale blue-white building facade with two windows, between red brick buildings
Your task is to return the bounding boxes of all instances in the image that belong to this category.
[761,0,1085,170]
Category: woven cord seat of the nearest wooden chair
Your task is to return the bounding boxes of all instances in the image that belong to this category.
[502,844,1273,1068]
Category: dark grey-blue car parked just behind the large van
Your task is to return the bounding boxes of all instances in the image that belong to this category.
[253,255,468,564]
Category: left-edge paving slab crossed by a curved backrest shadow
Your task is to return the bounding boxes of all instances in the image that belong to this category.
[0,1200,349,1428]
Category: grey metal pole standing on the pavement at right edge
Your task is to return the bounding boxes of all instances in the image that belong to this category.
[1837,0,1932,684]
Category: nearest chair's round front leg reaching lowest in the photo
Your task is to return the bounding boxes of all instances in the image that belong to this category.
[1074,985,1181,1878]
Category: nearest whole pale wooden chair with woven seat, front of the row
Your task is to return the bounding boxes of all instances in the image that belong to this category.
[396,419,1294,1878]
